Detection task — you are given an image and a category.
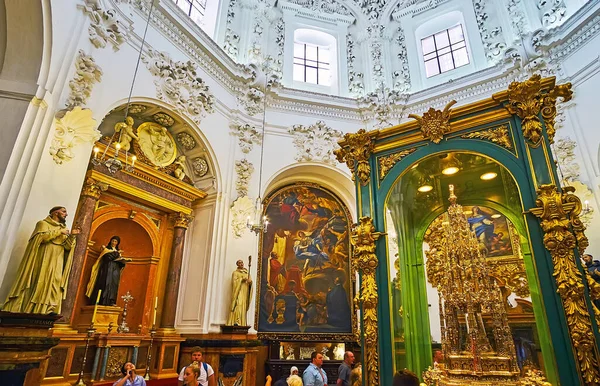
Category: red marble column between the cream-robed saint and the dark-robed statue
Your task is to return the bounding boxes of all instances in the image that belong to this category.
[59,177,108,323]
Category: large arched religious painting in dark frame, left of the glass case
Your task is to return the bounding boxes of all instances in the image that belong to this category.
[255,184,354,339]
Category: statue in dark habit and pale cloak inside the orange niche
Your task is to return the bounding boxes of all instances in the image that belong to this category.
[85,236,131,306]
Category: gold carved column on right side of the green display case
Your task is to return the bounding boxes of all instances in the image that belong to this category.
[530,185,600,385]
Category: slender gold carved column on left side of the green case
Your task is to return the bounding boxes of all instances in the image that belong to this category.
[350,217,384,386]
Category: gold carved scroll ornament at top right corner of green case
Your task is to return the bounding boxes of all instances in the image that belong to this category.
[506,74,573,146]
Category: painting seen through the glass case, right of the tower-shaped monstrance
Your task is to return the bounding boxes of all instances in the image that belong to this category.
[463,206,513,257]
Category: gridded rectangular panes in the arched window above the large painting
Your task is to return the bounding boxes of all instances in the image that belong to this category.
[294,42,331,86]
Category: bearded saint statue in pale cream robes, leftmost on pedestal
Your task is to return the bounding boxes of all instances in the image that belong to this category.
[2,206,79,314]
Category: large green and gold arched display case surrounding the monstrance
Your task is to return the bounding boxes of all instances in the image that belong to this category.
[336,75,600,386]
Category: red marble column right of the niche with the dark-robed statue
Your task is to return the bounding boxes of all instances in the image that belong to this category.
[160,213,191,329]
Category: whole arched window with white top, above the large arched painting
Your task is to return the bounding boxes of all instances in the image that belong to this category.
[293,28,337,88]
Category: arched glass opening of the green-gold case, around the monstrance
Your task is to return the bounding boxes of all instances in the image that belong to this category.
[386,152,555,381]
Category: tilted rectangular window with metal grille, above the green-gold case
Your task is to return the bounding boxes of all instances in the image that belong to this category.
[421,24,469,78]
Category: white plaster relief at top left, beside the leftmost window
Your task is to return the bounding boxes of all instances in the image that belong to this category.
[84,0,127,51]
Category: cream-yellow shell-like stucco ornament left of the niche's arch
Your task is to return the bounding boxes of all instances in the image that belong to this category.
[50,107,101,165]
